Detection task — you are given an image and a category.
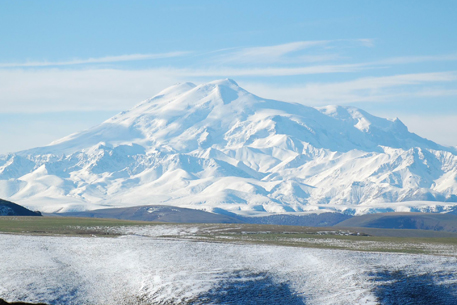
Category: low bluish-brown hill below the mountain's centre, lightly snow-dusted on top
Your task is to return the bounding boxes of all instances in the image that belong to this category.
[62,205,243,223]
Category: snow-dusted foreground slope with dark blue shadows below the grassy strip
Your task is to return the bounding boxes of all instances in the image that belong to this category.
[0,232,457,304]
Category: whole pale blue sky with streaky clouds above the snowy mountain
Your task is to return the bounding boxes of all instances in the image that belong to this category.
[0,0,457,153]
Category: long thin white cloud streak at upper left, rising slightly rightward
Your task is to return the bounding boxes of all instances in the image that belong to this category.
[0,52,189,68]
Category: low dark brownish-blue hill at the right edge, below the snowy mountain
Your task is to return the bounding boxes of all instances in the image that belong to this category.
[336,213,457,232]
